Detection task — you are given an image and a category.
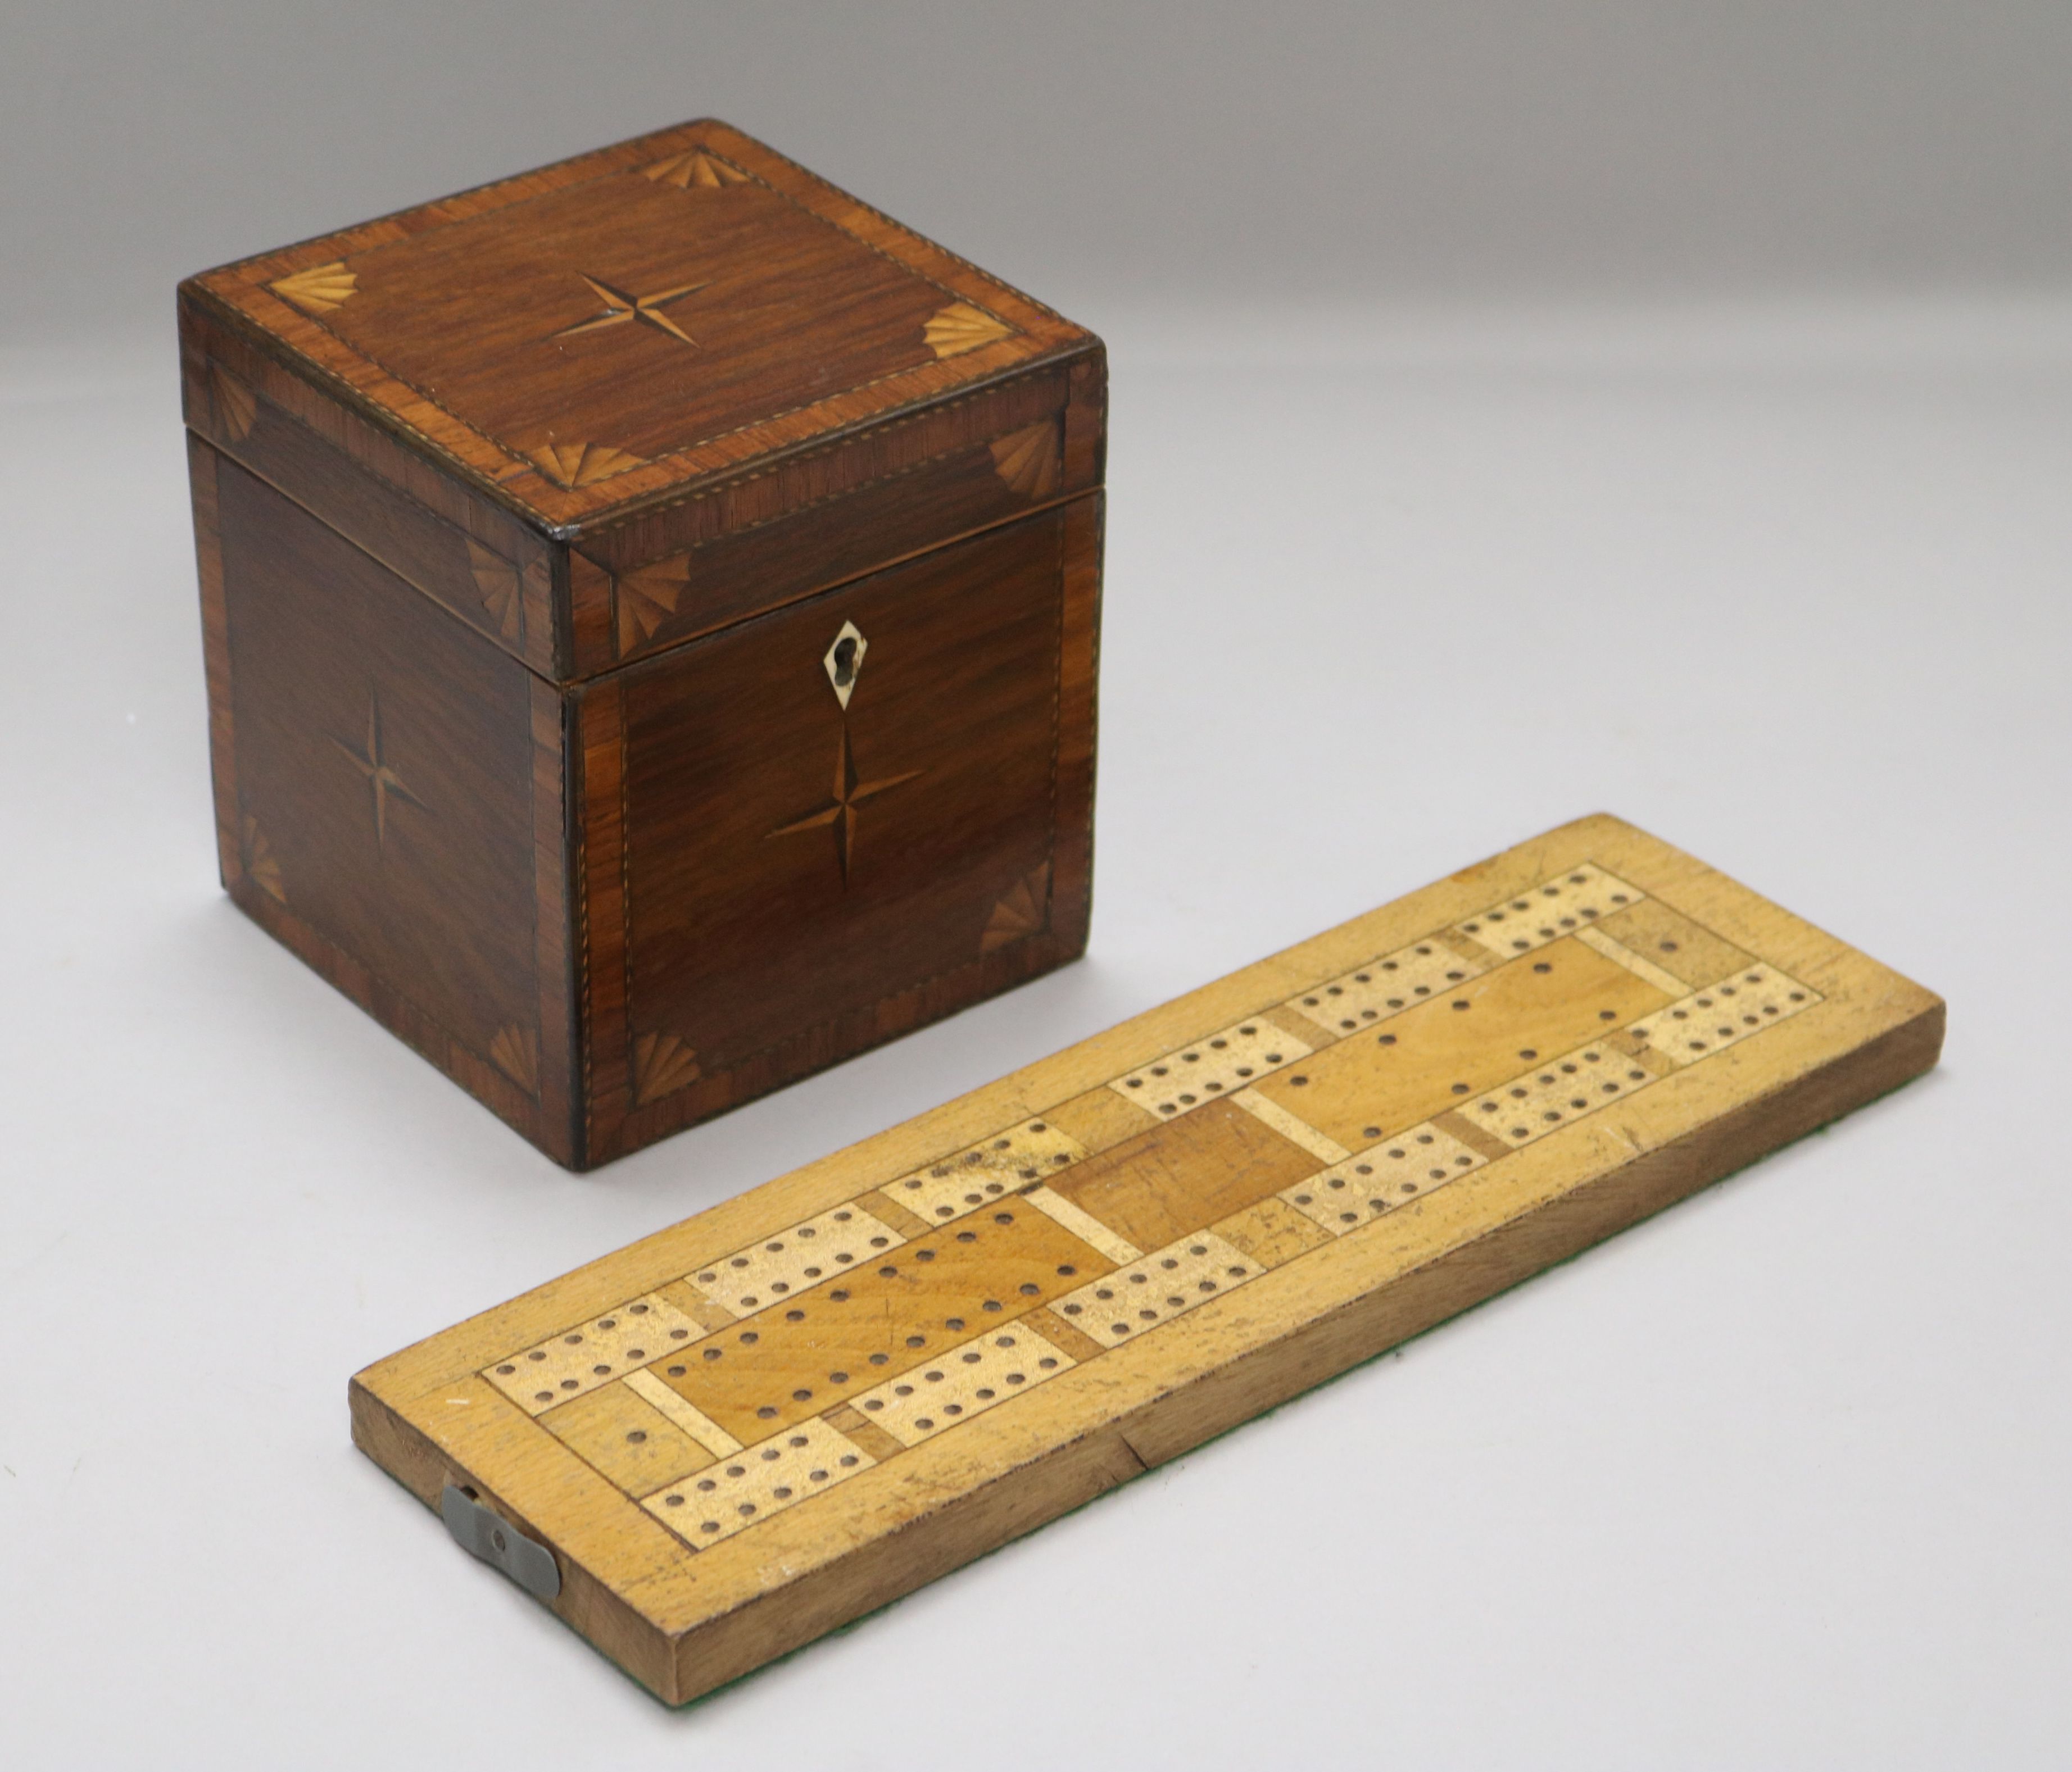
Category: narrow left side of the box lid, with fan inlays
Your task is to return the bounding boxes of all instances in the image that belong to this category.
[180,298,568,678]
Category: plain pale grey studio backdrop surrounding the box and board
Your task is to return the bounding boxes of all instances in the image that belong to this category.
[0,4,2072,1768]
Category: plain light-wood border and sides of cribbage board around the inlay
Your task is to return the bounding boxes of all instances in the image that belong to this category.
[352,815,1942,1702]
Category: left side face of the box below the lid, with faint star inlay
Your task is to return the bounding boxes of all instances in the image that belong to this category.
[195,442,574,1161]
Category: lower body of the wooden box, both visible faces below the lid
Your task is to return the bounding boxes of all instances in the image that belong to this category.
[195,470,1100,1167]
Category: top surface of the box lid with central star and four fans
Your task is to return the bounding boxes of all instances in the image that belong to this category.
[182,120,1100,541]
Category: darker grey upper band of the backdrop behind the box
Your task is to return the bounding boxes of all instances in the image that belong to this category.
[0,0,2072,342]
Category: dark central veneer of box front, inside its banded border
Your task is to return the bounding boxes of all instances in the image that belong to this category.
[625,518,1059,1071]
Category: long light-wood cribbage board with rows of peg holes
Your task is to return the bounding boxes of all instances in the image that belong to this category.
[352,816,1943,1702]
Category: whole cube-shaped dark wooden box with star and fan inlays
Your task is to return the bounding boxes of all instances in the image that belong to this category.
[180,122,1107,1169]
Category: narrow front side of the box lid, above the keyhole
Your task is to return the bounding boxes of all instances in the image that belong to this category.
[570,342,1107,676]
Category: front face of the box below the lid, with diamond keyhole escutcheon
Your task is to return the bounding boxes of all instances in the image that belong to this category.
[584,508,1094,1156]
